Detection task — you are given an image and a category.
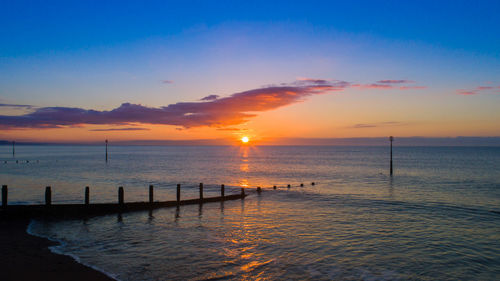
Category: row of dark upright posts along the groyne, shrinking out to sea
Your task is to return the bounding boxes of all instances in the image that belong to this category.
[2,182,315,207]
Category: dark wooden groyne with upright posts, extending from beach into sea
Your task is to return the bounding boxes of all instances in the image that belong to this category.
[0,183,246,219]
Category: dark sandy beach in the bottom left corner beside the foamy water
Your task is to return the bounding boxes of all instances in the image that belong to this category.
[0,219,115,281]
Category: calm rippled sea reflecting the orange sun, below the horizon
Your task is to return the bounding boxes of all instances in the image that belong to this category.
[0,146,500,280]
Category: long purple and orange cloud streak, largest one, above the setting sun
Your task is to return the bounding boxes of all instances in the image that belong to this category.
[0,80,349,129]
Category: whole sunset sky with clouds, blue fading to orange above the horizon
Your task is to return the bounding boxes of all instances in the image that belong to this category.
[0,0,500,142]
